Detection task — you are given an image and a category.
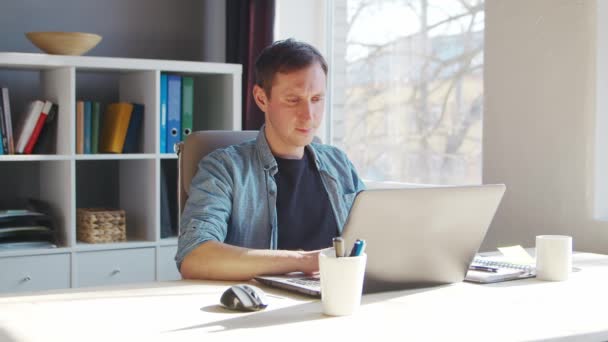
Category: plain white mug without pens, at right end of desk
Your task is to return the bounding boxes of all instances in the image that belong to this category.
[536,235,572,281]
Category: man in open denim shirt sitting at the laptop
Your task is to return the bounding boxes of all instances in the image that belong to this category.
[175,39,364,280]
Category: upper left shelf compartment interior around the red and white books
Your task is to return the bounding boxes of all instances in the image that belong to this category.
[0,67,75,155]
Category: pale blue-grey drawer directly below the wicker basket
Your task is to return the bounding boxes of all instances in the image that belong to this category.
[75,248,155,286]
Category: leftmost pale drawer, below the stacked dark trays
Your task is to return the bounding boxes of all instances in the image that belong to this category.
[0,254,70,292]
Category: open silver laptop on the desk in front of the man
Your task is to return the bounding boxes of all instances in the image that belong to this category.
[255,184,505,297]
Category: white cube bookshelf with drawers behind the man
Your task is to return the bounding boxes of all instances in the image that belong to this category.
[0,53,242,293]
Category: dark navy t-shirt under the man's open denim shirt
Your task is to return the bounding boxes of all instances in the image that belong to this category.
[274,150,338,251]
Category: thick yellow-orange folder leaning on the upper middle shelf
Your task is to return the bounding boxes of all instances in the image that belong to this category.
[99,102,133,153]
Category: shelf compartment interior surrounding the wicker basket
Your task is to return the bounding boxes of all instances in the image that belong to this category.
[75,159,157,245]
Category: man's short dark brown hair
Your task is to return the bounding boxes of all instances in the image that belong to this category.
[255,38,327,98]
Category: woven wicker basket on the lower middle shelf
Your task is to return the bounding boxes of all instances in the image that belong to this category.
[76,208,127,243]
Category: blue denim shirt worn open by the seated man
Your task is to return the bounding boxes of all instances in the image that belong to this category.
[175,127,364,270]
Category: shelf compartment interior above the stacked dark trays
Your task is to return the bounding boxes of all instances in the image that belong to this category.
[0,161,73,247]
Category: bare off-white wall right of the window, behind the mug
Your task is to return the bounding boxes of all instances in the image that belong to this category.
[483,0,608,253]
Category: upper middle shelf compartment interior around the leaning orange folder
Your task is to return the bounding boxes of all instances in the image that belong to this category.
[74,69,158,153]
